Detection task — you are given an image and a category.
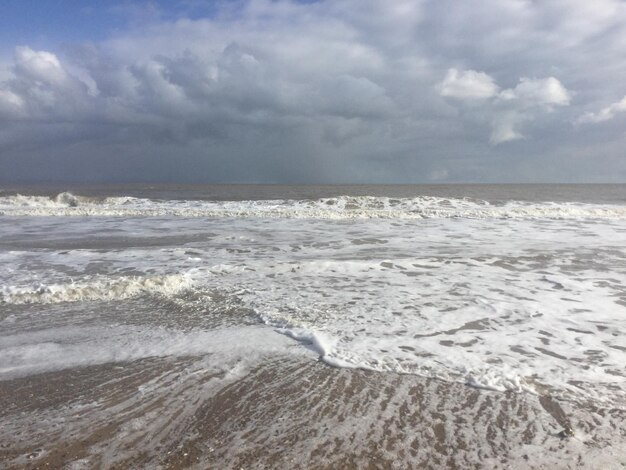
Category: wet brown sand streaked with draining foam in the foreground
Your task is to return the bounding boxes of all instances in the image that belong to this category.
[0,356,626,469]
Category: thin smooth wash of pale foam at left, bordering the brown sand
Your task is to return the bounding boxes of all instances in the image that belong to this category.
[0,325,307,379]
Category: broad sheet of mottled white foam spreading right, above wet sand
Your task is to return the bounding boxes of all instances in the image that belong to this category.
[238,250,626,398]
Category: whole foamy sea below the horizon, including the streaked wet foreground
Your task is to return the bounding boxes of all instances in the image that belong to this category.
[0,185,626,469]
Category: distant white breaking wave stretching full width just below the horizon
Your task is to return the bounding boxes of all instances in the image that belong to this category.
[0,192,626,220]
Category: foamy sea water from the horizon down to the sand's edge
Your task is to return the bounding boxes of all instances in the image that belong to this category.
[0,185,626,407]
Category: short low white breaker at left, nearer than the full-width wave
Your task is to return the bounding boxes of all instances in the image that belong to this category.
[0,274,192,304]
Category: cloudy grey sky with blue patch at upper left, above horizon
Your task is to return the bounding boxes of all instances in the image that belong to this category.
[0,0,626,184]
